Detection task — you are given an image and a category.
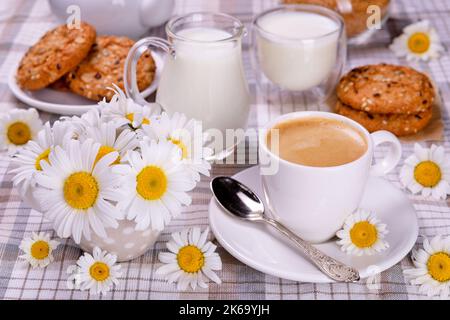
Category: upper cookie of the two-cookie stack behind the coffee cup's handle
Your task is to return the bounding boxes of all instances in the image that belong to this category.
[336,64,435,114]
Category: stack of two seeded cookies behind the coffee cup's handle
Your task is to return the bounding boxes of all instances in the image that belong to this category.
[336,64,435,136]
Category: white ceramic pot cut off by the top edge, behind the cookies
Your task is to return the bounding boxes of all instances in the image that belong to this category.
[49,0,175,39]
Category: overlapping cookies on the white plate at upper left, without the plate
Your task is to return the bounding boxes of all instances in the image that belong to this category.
[17,22,156,101]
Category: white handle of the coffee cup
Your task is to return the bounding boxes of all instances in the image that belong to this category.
[370,131,402,177]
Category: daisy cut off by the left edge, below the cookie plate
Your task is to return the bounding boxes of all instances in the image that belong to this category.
[0,109,42,155]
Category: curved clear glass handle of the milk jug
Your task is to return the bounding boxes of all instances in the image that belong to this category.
[124,37,175,110]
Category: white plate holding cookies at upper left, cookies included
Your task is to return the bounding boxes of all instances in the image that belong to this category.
[8,22,163,115]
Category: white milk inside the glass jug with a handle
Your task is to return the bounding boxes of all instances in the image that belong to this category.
[156,28,250,132]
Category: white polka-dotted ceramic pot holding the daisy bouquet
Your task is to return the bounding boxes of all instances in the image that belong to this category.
[17,184,161,262]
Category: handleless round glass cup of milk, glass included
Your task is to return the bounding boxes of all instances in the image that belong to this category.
[252,5,347,102]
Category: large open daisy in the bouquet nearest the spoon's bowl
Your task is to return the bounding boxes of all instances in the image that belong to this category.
[113,140,195,230]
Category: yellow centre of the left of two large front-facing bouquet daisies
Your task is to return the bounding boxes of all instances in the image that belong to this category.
[64,172,99,210]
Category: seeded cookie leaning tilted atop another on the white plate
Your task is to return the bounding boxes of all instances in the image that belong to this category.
[16,22,96,90]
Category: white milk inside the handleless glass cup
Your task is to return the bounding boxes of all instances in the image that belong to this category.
[257,11,339,91]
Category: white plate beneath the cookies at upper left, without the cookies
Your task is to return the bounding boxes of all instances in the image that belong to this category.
[8,52,164,116]
